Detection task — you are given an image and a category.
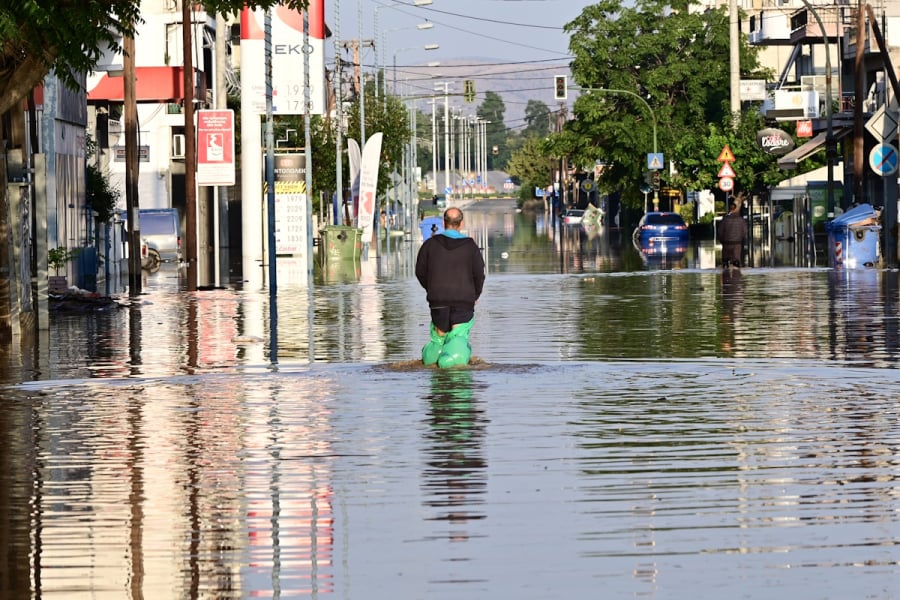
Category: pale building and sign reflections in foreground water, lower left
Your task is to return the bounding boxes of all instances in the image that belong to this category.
[0,376,334,600]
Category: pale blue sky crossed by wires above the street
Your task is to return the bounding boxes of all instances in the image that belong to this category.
[325,0,592,126]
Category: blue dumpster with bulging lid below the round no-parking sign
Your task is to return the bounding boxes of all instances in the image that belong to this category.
[825,204,881,269]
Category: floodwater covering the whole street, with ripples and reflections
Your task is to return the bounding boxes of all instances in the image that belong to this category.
[0,202,900,600]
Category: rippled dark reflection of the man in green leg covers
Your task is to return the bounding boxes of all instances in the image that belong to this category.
[423,369,487,541]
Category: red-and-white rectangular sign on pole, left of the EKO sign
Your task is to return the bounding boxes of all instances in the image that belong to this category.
[197,109,235,185]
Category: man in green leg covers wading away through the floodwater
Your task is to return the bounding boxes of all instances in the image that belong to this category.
[416,208,484,369]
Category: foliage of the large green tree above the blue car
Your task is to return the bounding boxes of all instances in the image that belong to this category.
[554,0,766,206]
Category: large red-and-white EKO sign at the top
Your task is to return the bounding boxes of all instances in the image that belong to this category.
[241,0,326,115]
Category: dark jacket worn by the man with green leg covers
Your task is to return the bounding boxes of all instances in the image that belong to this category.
[416,234,484,310]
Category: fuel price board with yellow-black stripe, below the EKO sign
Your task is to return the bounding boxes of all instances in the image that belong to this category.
[275,154,307,256]
